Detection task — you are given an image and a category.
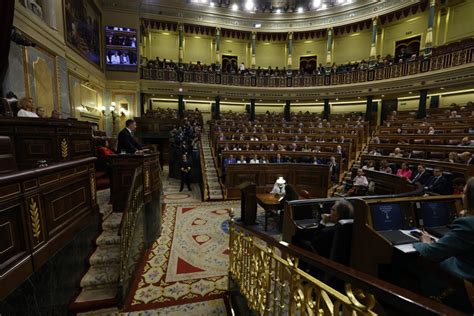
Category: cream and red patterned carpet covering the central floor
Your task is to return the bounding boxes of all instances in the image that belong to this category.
[124,202,239,311]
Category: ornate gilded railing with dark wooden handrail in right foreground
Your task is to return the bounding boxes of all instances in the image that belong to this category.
[229,214,460,315]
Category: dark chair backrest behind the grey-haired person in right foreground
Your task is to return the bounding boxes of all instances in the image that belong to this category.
[329,219,354,266]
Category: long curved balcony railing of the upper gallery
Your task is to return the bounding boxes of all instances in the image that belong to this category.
[141,42,474,88]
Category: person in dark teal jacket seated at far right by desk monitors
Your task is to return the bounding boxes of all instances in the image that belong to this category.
[413,178,474,282]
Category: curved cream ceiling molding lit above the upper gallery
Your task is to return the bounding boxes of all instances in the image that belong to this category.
[104,0,421,32]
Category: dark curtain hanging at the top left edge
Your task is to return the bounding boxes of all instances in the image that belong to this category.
[0,0,15,97]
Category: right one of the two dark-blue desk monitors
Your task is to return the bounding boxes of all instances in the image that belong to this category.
[420,201,454,227]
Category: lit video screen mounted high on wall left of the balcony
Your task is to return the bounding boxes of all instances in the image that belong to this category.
[105,26,138,72]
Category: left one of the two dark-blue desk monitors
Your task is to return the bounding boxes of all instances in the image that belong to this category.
[370,203,404,231]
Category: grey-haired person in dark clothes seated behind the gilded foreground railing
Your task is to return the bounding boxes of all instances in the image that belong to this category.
[310,200,354,258]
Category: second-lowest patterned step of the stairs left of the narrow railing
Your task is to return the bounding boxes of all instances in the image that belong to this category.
[81,264,120,289]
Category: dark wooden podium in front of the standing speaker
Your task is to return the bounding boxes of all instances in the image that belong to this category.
[109,152,161,212]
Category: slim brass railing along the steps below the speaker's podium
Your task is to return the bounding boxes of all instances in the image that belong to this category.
[119,167,145,298]
